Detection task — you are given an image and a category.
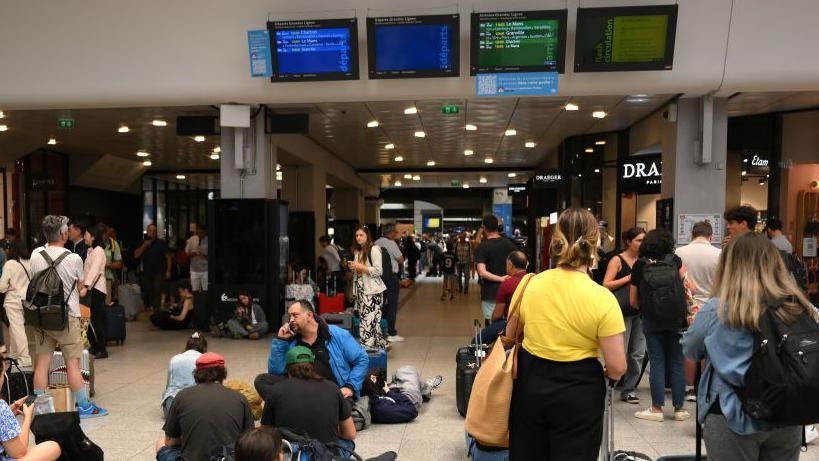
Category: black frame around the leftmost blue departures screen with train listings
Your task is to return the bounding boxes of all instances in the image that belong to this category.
[267,18,360,83]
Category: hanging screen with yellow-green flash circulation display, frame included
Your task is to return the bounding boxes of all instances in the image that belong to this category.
[574,5,677,72]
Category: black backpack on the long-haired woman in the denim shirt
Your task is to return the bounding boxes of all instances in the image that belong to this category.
[737,306,819,426]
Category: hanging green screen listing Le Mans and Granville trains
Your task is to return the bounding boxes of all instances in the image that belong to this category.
[470,10,567,75]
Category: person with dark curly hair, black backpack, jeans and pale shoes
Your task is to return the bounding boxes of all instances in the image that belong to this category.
[630,229,691,423]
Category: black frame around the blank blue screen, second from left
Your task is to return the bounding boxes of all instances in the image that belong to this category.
[367,13,461,80]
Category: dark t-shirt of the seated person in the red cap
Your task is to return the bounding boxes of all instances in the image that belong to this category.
[163,383,254,461]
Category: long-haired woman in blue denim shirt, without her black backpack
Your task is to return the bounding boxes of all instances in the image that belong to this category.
[682,232,819,461]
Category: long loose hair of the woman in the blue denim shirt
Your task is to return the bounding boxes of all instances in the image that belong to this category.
[713,232,816,331]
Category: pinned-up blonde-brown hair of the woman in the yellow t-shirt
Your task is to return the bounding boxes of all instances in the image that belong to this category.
[549,208,600,269]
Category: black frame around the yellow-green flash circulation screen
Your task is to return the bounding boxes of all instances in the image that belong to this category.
[574,4,679,72]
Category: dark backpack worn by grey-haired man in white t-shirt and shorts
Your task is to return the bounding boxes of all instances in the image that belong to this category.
[23,250,76,331]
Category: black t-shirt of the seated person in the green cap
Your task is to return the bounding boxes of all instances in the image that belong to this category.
[262,378,352,443]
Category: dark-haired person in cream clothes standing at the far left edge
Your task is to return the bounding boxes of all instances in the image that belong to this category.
[0,240,32,368]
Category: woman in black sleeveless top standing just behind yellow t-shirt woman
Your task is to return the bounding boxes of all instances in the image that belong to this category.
[603,227,646,404]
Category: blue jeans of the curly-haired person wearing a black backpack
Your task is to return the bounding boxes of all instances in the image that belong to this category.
[643,330,685,408]
